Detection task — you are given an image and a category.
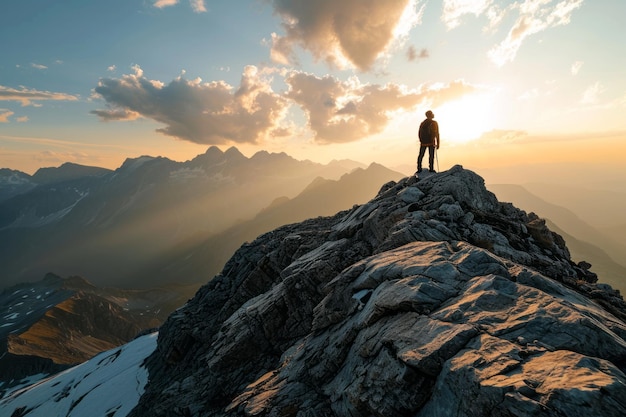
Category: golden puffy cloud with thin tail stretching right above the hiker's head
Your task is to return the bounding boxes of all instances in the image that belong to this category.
[285,71,475,143]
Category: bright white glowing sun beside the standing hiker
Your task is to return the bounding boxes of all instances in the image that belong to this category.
[433,93,496,143]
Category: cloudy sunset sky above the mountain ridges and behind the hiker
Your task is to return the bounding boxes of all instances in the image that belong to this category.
[0,0,626,174]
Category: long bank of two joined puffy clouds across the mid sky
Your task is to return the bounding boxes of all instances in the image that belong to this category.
[91,66,477,145]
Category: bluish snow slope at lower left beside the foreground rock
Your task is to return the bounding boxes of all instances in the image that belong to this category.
[0,332,158,417]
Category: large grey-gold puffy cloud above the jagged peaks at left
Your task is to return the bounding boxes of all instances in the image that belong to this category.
[91,66,288,144]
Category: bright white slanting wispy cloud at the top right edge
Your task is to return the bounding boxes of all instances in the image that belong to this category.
[488,0,583,66]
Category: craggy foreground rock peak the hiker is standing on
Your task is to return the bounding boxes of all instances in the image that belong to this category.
[130,166,626,417]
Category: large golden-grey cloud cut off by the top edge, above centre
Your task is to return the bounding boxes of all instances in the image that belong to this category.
[271,0,419,71]
